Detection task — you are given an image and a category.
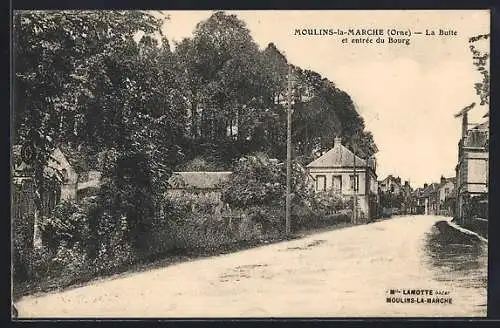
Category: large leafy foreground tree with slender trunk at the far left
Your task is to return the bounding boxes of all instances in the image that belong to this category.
[14,11,178,247]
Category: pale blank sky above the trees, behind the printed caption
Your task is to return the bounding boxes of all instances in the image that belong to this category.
[155,10,490,187]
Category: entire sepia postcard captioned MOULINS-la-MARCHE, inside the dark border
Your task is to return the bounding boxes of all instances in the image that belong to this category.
[11,10,490,319]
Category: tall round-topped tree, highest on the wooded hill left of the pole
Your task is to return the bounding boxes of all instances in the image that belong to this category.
[174,12,280,162]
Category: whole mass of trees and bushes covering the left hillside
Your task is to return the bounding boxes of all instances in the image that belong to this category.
[13,11,376,290]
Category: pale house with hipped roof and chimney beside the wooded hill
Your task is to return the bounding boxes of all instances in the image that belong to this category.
[307,137,378,221]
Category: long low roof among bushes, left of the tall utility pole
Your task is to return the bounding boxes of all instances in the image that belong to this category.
[168,171,233,189]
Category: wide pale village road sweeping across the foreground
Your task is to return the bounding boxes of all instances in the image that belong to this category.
[17,216,487,318]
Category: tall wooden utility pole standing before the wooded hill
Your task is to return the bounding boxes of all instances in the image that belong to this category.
[285,64,292,236]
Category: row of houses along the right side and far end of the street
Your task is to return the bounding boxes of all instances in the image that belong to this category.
[394,103,489,224]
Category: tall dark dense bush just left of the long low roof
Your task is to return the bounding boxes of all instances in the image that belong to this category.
[97,151,169,255]
